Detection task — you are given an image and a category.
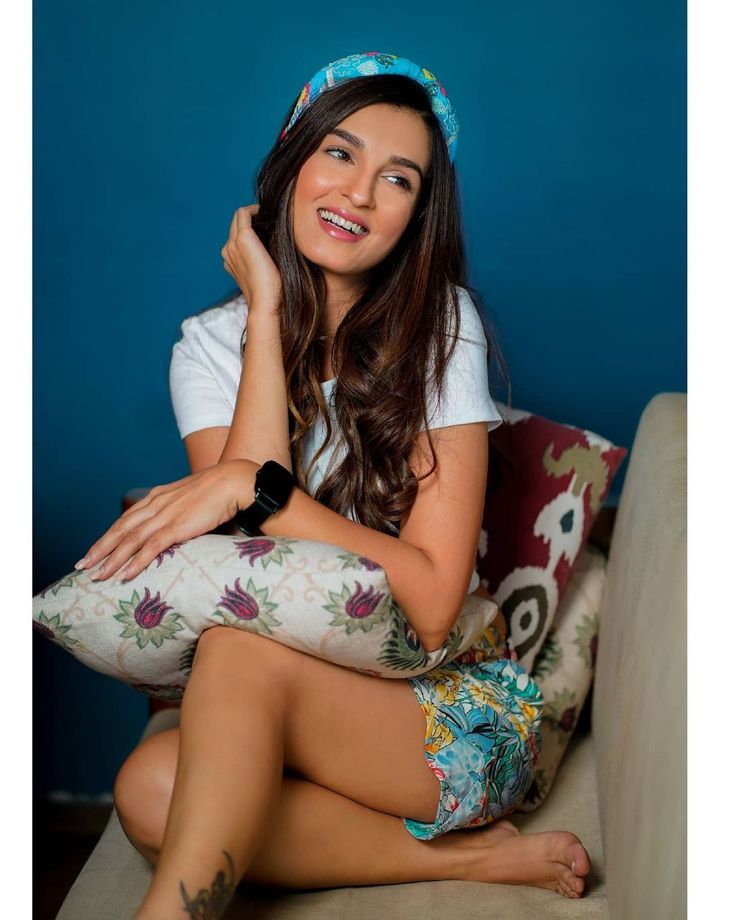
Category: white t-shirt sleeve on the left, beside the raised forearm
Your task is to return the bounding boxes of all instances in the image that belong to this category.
[169,296,243,439]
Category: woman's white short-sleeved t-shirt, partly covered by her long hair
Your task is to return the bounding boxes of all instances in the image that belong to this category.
[169,288,502,594]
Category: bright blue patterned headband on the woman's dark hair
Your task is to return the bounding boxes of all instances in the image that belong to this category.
[281,51,459,163]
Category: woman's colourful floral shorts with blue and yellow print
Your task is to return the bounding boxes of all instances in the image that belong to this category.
[402,623,544,840]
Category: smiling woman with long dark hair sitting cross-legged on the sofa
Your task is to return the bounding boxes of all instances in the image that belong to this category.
[79,54,590,918]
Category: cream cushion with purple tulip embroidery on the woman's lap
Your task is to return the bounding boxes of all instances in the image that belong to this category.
[33,534,498,699]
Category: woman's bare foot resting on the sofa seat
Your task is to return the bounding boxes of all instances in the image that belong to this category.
[462,821,590,898]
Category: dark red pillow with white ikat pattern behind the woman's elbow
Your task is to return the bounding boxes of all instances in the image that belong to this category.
[477,406,627,673]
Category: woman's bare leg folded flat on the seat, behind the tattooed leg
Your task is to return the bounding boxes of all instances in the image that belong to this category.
[115,729,589,897]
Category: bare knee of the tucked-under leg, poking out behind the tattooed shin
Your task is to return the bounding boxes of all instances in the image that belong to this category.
[113,729,179,849]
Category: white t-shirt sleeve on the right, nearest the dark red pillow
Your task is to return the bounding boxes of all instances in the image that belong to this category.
[427,288,503,431]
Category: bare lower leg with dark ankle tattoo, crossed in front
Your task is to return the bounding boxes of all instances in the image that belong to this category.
[136,628,288,920]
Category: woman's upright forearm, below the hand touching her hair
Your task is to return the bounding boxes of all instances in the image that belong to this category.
[220,304,291,470]
